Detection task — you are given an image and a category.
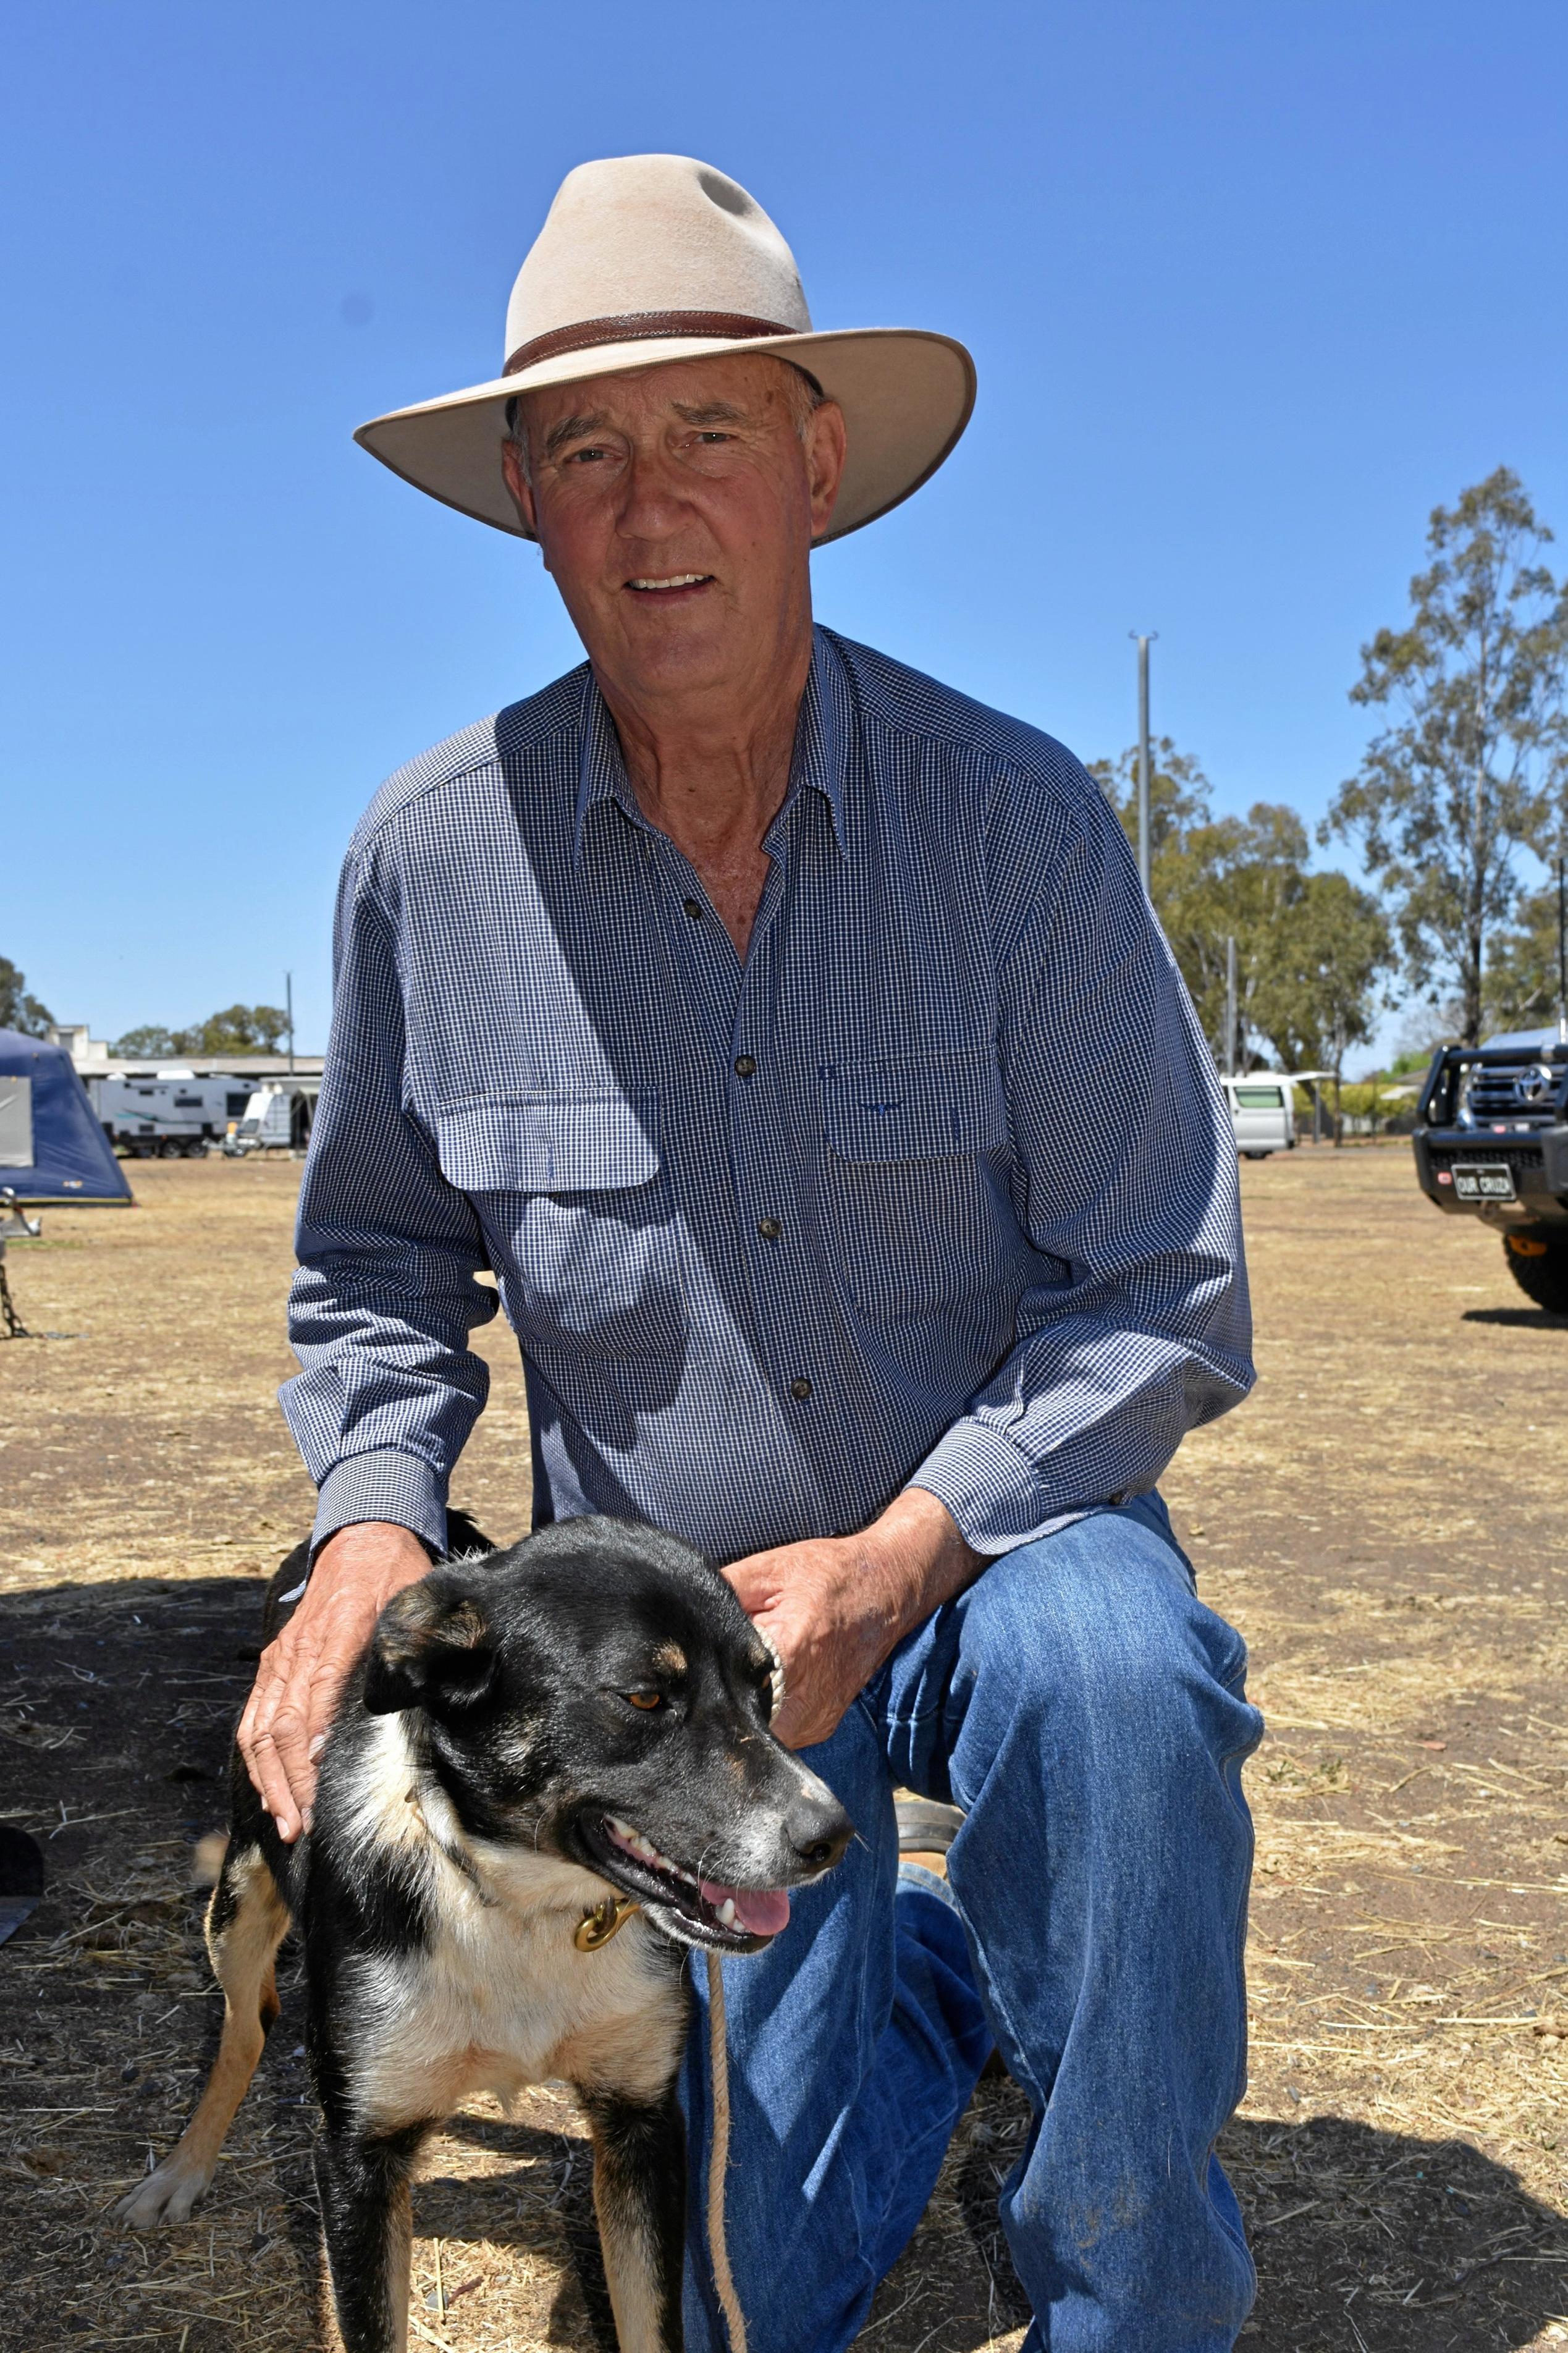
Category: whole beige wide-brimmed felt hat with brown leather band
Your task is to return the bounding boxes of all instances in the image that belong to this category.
[353,155,975,541]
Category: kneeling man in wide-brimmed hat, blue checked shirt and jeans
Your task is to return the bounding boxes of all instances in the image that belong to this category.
[243,155,1260,2353]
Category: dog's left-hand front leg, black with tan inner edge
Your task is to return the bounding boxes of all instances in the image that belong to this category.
[316,2125,431,2353]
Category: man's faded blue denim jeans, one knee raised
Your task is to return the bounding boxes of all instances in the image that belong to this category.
[683,1497,1262,2353]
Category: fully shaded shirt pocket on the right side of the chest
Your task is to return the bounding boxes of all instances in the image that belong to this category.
[822,1049,1022,1348]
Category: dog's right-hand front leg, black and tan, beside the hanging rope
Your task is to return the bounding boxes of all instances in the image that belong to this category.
[584,2085,685,2353]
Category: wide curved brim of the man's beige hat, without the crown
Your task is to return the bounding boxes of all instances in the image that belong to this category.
[353,327,975,544]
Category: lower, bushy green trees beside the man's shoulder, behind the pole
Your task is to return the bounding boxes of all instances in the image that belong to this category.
[1090,737,1391,1071]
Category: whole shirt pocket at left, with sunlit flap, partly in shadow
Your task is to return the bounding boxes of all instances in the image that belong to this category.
[433,1089,685,1379]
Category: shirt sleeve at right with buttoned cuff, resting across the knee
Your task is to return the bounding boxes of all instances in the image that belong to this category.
[909,788,1252,1555]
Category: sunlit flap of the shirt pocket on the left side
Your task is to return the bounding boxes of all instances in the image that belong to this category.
[436,1094,659,1193]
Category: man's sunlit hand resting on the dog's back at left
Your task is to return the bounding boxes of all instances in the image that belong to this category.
[240,1520,431,1844]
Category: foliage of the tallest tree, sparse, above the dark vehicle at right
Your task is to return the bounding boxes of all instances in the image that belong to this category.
[1318,466,1568,1045]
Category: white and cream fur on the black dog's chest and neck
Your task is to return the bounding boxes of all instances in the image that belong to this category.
[342,1715,685,2132]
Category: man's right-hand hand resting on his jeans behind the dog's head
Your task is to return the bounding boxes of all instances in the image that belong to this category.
[725,1487,984,1748]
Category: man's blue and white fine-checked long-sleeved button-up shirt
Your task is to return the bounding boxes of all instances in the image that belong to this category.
[282,631,1252,1560]
